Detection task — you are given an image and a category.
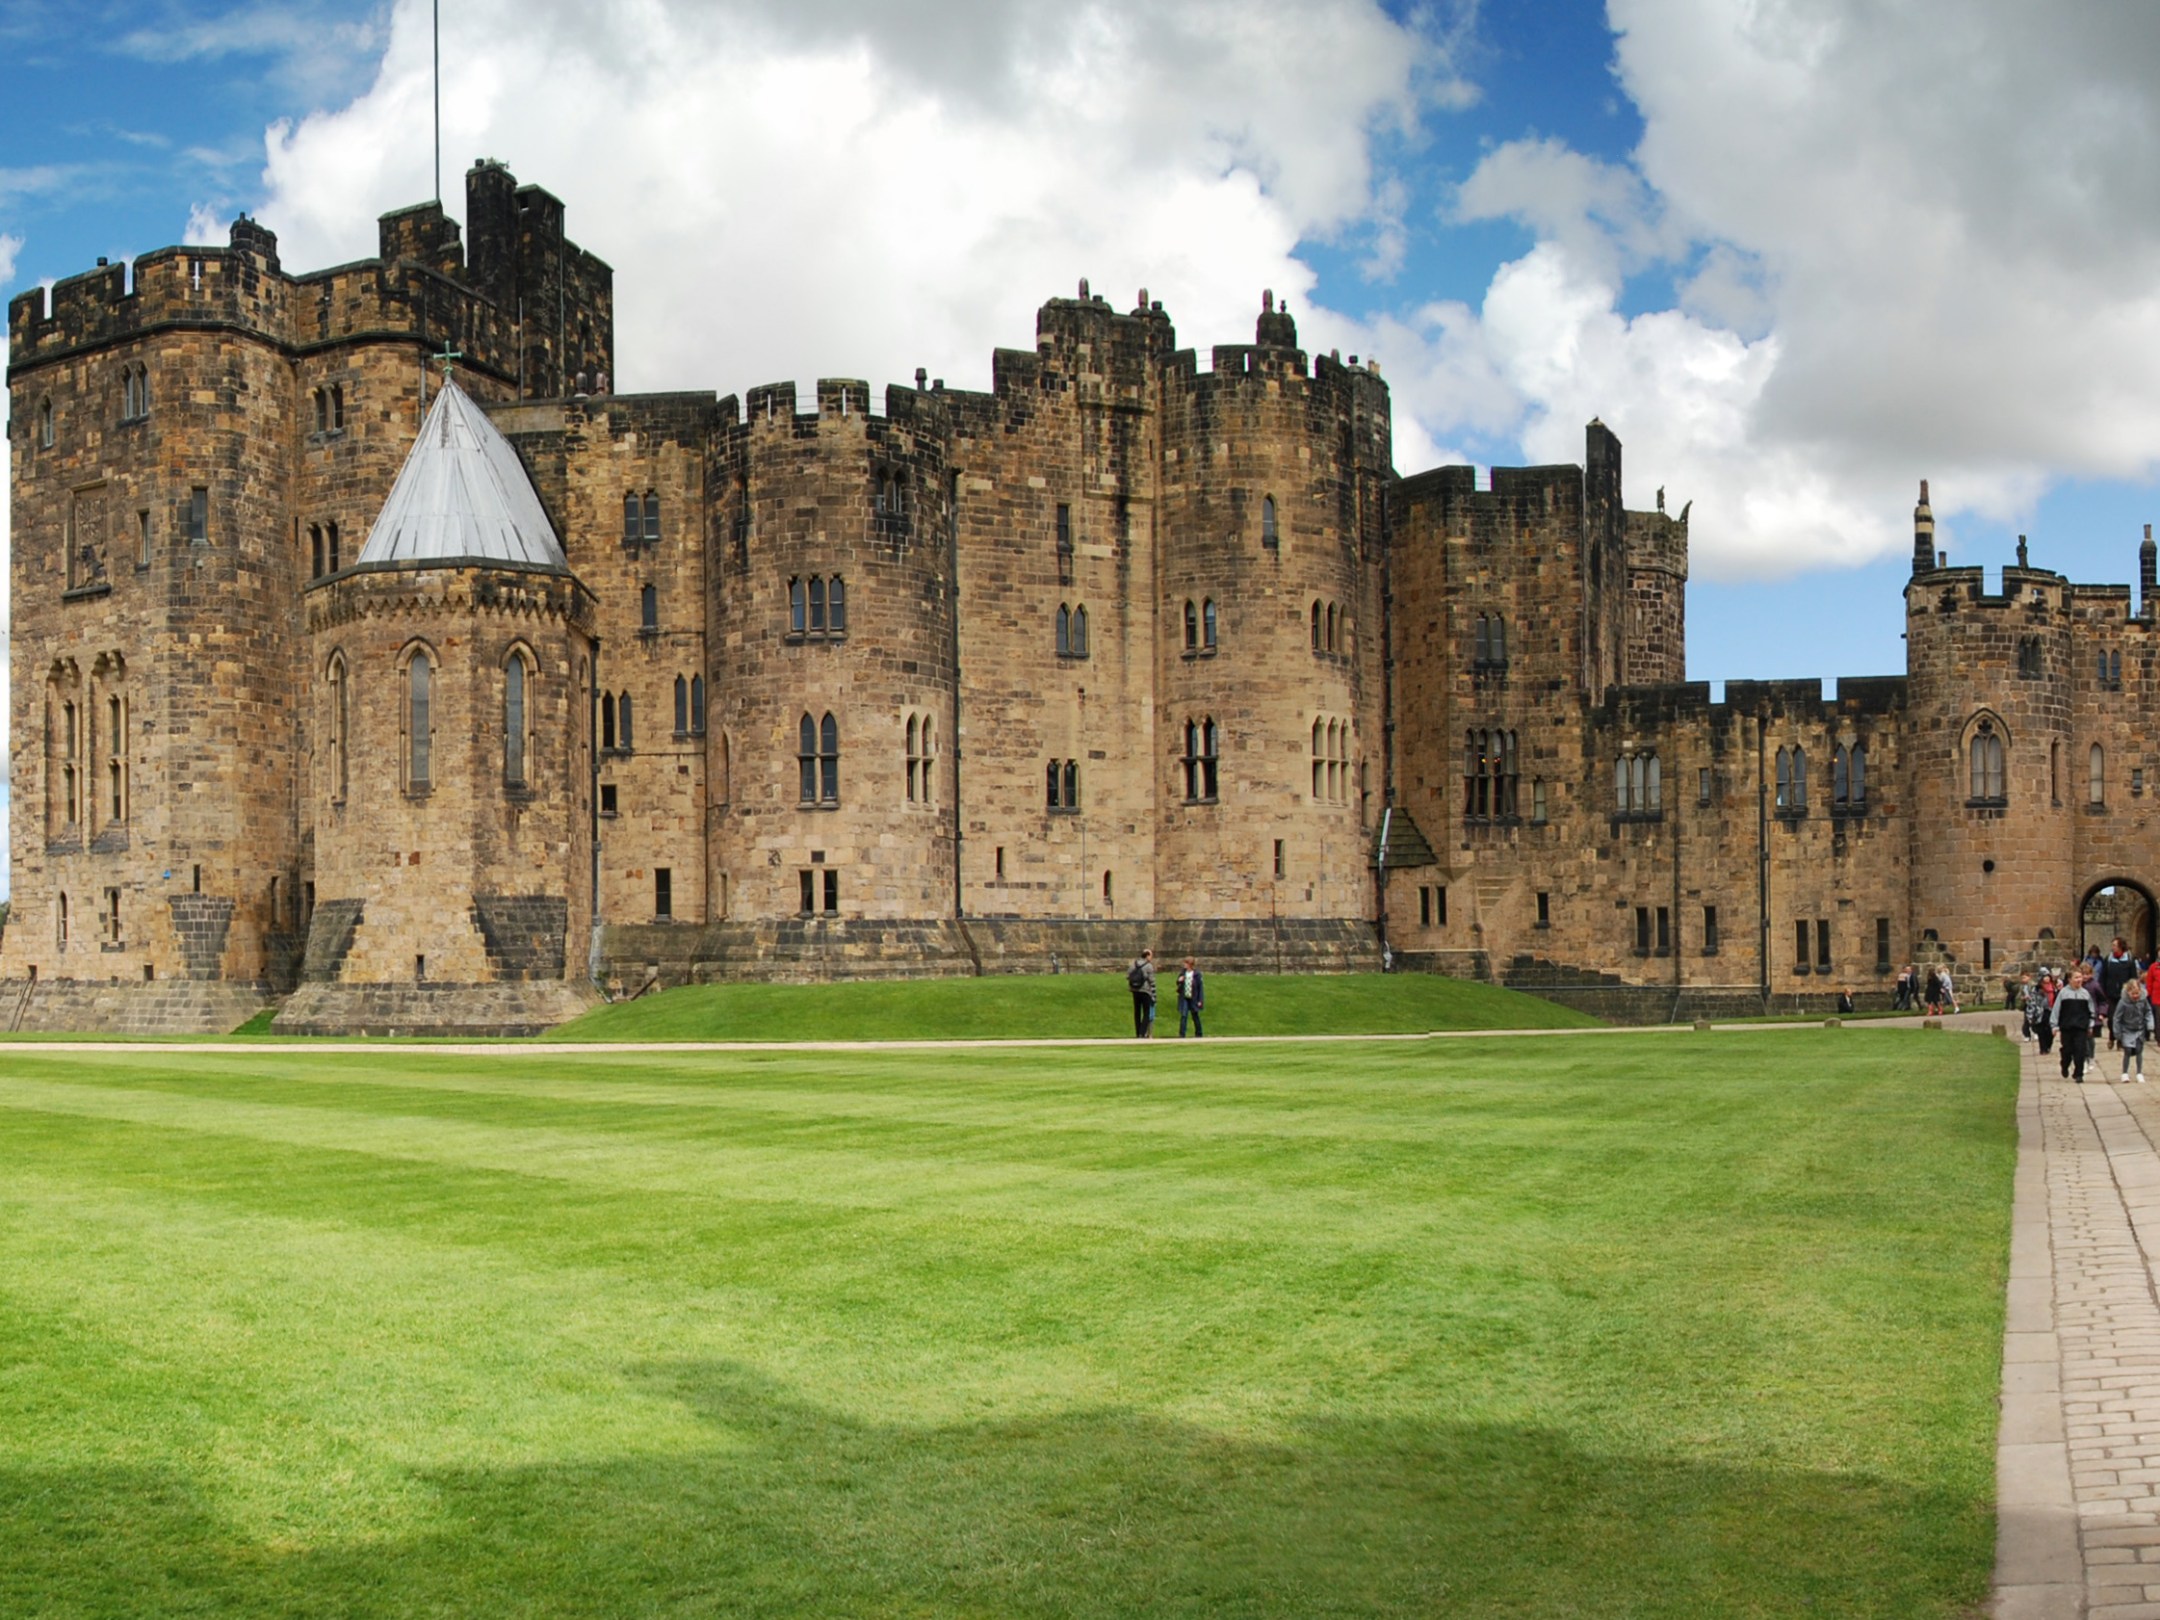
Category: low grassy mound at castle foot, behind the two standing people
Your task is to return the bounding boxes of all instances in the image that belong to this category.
[546,970,1598,1041]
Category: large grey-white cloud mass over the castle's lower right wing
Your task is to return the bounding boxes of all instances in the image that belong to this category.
[1425,0,2160,575]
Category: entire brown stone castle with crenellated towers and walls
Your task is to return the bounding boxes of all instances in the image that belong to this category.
[0,162,2156,1032]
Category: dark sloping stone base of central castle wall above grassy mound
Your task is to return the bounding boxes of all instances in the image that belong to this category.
[600,918,1380,991]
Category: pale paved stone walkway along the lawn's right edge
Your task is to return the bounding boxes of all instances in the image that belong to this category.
[1996,1045,2160,1620]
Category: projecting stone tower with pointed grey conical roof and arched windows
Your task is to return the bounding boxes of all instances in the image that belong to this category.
[276,382,594,1035]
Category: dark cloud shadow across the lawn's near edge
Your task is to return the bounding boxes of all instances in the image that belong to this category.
[0,1365,1994,1620]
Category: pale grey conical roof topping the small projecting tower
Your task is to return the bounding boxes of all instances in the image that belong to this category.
[359,382,570,572]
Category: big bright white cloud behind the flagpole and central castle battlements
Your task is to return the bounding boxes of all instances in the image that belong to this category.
[261,0,1454,412]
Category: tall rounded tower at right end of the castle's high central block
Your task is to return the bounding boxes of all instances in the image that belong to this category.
[1156,294,1385,920]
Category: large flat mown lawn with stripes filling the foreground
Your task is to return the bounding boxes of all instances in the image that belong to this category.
[0,1030,2015,1620]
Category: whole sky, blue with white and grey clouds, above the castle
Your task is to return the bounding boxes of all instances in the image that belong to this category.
[0,0,2160,851]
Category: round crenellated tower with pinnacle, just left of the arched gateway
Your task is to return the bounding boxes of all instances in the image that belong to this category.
[1903,482,2076,985]
